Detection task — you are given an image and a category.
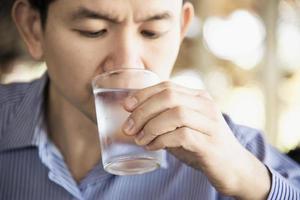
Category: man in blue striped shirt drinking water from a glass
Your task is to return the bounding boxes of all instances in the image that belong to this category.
[0,0,300,200]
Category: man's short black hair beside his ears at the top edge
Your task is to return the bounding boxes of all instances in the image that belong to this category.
[28,0,189,26]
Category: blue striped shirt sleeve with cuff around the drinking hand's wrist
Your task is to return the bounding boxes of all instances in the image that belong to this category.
[230,116,300,200]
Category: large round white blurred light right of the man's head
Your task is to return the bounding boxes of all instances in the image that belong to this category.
[203,10,266,69]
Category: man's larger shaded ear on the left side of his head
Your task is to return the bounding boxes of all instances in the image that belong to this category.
[12,0,43,60]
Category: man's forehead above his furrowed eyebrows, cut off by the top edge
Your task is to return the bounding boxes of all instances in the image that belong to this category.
[49,0,182,19]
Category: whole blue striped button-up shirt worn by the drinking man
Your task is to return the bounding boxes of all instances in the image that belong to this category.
[0,76,300,200]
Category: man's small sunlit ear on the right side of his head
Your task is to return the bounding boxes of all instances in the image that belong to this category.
[181,2,195,41]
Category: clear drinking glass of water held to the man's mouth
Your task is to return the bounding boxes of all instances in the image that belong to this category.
[92,68,164,175]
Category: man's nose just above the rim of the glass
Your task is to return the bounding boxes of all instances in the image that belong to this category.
[104,31,145,71]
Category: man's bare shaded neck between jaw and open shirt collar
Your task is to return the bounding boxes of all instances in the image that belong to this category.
[46,82,101,182]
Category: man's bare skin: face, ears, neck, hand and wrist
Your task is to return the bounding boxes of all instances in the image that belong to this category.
[13,0,271,199]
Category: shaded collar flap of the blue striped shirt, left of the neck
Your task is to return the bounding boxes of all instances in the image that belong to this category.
[0,73,48,151]
